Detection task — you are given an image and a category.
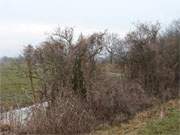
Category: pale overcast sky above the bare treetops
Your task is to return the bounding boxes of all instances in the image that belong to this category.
[0,0,180,57]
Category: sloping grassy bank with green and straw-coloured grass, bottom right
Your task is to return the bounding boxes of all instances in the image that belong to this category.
[91,100,180,135]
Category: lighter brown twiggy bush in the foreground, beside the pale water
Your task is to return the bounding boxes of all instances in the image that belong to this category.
[22,93,97,135]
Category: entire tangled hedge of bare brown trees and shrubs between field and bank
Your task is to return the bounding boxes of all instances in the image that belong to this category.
[0,21,180,135]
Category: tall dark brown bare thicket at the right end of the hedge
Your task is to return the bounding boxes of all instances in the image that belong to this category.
[123,22,180,100]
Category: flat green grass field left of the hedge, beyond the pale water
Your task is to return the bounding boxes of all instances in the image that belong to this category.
[0,60,31,107]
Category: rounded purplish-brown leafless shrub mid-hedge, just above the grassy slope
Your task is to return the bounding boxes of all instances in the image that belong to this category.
[88,76,151,122]
